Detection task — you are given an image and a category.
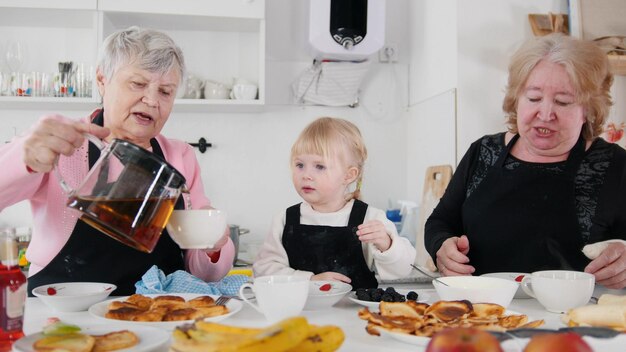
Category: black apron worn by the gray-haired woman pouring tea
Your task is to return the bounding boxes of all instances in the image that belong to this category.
[28,111,184,297]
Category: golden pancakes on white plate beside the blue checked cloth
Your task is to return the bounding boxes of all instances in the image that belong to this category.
[104,294,228,322]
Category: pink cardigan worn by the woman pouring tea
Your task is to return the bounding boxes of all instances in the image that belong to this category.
[0,115,235,281]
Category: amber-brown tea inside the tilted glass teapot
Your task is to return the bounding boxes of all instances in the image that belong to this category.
[67,196,176,253]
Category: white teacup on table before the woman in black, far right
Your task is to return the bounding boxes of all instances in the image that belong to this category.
[521,270,596,313]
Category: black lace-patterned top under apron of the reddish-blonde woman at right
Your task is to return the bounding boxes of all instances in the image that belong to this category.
[425,133,626,266]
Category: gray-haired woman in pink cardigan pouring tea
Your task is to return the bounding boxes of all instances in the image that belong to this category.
[0,27,234,295]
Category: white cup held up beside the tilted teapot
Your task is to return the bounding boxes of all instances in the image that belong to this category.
[166,209,226,249]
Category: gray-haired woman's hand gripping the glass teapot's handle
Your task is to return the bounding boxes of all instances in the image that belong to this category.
[24,115,109,172]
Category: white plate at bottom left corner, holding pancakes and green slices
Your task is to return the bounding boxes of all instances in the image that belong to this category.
[13,323,170,352]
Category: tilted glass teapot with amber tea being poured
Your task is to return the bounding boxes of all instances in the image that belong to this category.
[55,134,186,253]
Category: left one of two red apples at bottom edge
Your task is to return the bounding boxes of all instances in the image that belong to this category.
[426,328,502,352]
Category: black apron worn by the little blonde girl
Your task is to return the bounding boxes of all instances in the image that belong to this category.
[283,199,378,290]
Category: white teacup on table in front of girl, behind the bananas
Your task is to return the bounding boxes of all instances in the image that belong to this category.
[239,275,309,323]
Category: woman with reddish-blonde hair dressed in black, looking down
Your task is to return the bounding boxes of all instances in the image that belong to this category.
[425,34,626,288]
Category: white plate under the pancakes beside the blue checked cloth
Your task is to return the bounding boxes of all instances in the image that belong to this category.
[89,293,242,330]
